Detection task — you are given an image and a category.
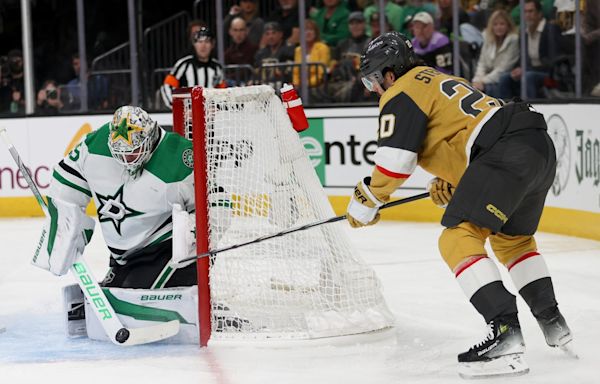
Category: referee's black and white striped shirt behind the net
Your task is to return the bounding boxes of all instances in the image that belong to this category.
[160,55,224,108]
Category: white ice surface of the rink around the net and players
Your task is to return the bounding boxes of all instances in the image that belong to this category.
[0,219,600,384]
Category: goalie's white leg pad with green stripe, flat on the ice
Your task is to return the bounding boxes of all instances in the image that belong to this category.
[85,285,198,344]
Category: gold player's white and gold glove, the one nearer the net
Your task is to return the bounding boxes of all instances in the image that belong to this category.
[346,177,383,228]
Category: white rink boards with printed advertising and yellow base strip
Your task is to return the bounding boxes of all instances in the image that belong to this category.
[0,104,600,240]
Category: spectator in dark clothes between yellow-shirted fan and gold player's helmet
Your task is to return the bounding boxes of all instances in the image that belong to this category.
[329,11,370,102]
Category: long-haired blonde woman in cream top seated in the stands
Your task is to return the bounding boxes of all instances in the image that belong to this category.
[472,9,519,97]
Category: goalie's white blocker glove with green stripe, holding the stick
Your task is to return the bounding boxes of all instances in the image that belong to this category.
[31,197,96,276]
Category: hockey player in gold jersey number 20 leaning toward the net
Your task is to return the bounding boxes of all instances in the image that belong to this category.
[347,32,572,377]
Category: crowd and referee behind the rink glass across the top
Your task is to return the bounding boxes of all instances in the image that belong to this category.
[0,0,600,115]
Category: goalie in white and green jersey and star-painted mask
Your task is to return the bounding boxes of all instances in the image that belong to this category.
[33,106,196,289]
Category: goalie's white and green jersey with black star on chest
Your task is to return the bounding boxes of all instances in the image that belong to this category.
[48,124,194,264]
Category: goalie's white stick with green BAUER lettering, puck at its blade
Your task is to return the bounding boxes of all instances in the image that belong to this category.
[0,128,179,346]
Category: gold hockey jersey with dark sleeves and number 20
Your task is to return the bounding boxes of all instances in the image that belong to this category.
[371,66,502,201]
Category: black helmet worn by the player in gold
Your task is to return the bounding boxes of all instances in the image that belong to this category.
[360,31,419,88]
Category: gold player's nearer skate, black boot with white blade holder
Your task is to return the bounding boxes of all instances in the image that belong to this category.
[458,314,529,379]
